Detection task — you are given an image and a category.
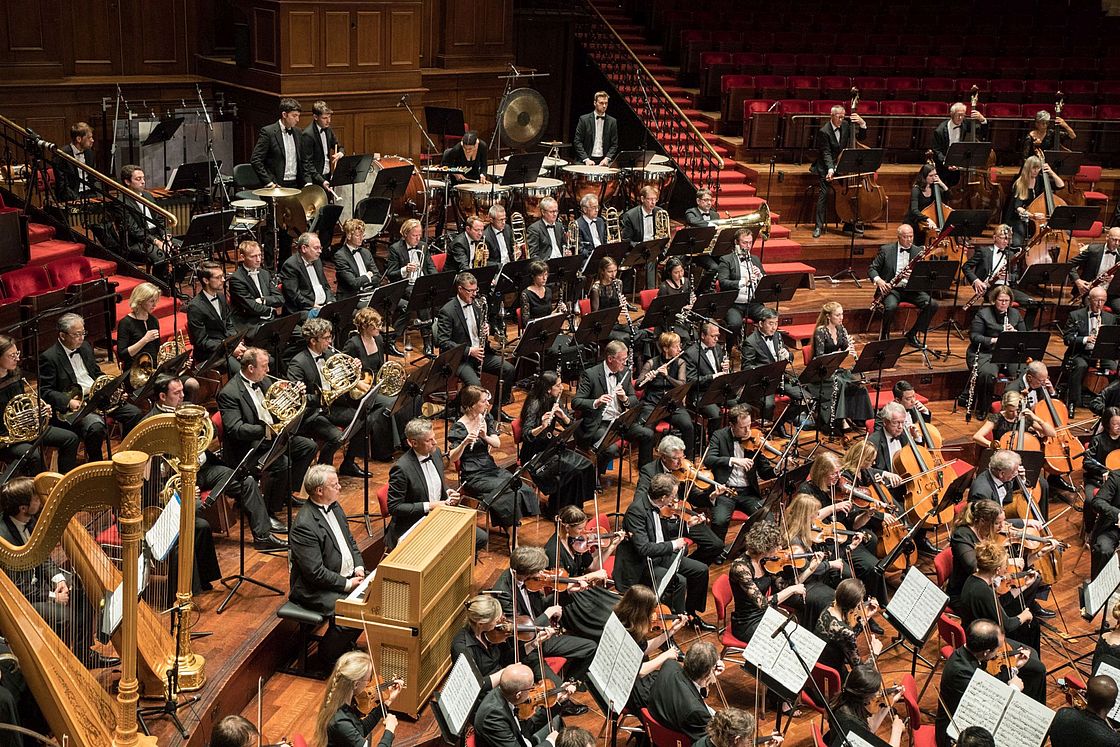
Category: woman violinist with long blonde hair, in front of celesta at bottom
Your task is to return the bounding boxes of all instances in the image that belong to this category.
[311,651,401,747]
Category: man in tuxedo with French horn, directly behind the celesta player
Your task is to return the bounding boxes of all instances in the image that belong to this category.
[217,347,316,514]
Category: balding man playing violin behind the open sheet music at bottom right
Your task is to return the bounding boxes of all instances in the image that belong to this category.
[934,619,1046,747]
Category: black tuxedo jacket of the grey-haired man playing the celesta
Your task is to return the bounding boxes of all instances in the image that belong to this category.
[288,501,365,615]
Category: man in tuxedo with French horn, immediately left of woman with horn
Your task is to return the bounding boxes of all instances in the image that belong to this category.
[288,318,368,477]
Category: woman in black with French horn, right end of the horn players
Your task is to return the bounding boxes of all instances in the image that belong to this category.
[344,308,419,461]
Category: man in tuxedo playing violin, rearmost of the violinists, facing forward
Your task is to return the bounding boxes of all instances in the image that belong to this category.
[703,404,776,539]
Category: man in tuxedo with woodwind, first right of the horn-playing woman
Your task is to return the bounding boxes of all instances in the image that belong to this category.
[436,272,514,422]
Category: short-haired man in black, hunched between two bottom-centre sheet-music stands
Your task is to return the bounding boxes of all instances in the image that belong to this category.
[650,641,724,741]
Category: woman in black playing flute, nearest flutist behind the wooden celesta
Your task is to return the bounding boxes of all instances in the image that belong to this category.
[447,385,541,526]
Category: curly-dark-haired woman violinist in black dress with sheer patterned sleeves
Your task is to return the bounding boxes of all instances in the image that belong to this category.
[728,521,805,641]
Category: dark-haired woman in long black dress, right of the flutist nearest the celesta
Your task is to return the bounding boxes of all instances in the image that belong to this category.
[521,371,595,519]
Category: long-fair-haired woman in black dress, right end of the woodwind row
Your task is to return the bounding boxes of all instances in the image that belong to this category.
[805,301,875,432]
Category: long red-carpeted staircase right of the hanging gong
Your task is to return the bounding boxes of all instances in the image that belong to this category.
[580,0,801,264]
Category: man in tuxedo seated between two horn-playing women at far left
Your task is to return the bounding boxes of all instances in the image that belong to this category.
[39,314,143,461]
